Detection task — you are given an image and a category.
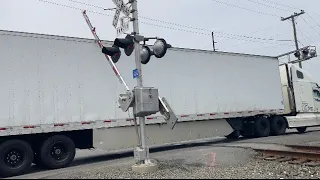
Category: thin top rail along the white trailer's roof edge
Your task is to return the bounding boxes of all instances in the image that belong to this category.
[0,30,278,60]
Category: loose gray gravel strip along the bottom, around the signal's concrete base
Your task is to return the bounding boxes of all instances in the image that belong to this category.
[46,158,320,179]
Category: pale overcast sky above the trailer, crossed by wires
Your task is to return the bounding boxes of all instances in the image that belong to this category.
[0,0,320,82]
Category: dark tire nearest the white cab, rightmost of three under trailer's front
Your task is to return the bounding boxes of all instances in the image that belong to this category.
[270,116,287,136]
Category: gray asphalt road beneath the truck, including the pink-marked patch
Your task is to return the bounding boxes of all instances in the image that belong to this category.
[8,128,320,179]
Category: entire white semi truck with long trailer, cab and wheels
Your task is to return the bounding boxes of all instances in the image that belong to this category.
[0,31,320,176]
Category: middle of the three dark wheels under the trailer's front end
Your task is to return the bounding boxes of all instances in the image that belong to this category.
[254,117,270,137]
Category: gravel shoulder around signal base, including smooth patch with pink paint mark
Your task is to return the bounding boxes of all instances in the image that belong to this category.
[43,147,320,179]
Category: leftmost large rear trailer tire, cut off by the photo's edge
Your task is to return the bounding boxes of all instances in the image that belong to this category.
[0,140,33,177]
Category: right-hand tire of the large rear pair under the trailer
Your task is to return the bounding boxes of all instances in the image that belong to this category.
[40,135,76,169]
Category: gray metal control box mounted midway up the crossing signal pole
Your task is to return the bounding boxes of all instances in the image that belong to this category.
[133,87,159,117]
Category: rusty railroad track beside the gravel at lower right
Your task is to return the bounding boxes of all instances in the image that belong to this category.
[254,145,320,166]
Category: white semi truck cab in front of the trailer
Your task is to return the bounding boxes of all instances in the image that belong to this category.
[280,64,320,129]
